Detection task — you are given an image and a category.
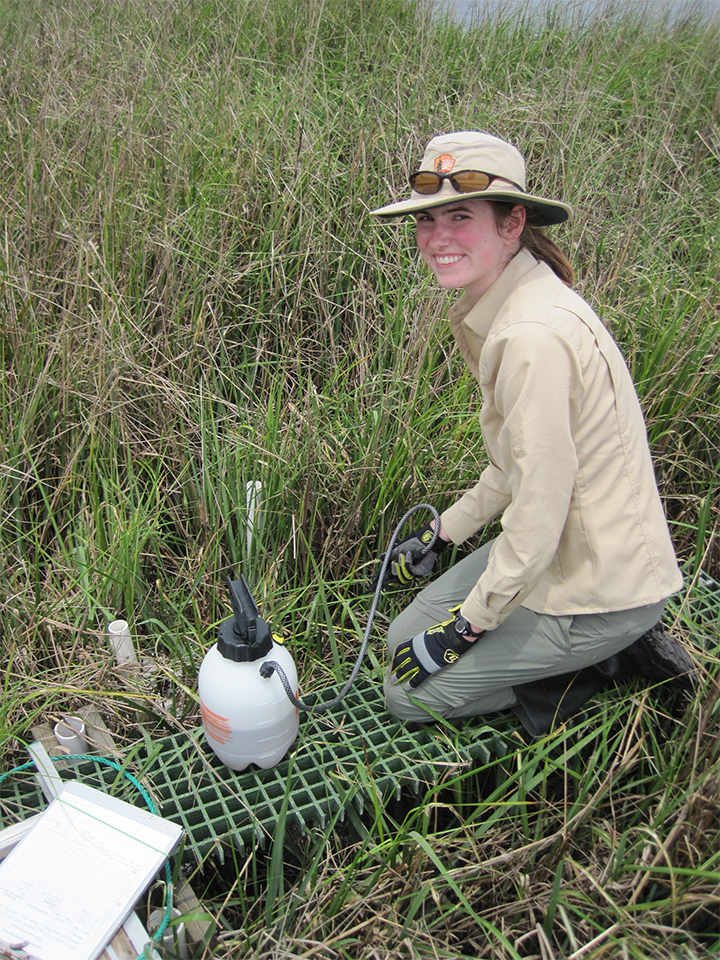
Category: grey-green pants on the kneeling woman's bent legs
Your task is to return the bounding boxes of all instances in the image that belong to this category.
[385,543,665,721]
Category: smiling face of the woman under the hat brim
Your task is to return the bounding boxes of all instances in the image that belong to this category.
[415,197,525,301]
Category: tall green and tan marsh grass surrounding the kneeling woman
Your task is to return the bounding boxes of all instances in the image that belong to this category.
[0,0,720,960]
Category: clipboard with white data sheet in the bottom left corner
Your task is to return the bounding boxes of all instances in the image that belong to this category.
[0,783,182,960]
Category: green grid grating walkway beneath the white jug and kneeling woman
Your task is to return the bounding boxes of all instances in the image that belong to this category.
[5,575,720,862]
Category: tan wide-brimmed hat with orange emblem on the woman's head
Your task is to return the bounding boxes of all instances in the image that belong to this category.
[371,130,572,225]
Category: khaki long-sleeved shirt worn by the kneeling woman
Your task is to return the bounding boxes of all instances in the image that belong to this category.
[442,250,682,629]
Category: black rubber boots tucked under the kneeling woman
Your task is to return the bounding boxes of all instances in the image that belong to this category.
[513,623,697,737]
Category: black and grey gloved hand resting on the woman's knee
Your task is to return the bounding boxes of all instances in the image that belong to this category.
[390,606,485,688]
